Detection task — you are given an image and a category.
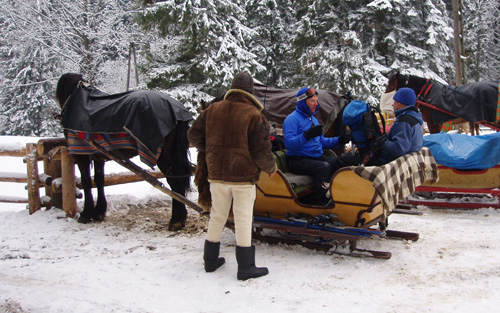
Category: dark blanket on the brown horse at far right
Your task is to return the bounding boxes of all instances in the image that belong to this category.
[421,81,500,124]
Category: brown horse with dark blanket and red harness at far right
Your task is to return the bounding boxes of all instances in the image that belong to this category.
[385,72,500,134]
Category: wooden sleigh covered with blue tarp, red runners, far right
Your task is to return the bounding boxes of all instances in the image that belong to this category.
[407,133,500,209]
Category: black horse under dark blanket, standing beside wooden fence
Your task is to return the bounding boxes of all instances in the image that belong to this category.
[56,73,194,231]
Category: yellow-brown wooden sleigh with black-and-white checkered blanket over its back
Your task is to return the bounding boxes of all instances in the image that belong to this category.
[254,148,437,258]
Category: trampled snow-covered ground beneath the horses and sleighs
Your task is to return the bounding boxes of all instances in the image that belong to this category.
[0,137,500,313]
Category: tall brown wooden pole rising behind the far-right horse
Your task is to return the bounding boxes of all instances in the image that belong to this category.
[451,0,466,86]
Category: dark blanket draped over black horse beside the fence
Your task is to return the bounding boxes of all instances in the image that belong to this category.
[62,86,193,163]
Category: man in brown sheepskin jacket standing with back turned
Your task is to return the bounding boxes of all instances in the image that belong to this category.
[188,72,277,280]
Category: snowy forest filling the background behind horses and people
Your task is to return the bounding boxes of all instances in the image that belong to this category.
[0,0,500,136]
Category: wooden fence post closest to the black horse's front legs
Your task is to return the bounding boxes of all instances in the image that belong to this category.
[61,147,76,217]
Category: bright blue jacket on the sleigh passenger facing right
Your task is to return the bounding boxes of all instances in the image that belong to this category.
[283,101,339,158]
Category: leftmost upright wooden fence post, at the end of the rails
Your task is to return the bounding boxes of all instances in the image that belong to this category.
[26,143,42,214]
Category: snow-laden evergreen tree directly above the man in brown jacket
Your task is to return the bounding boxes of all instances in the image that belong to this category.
[134,0,265,95]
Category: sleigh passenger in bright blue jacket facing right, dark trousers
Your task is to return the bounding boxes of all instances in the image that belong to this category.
[283,87,352,205]
